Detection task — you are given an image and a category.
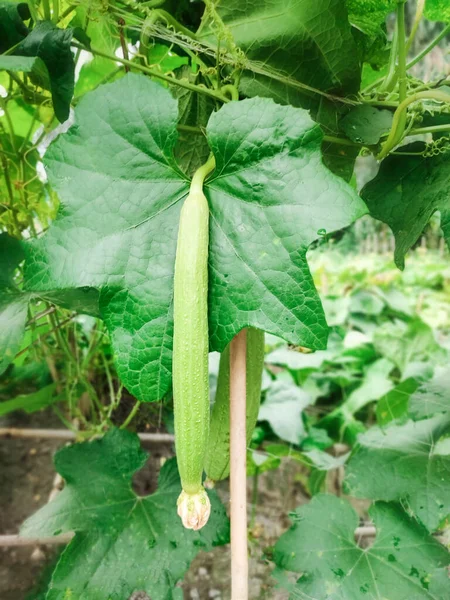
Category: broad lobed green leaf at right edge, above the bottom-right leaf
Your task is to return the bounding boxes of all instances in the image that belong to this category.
[345,414,450,531]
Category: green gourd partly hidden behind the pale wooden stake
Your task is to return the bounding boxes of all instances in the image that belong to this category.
[205,327,264,481]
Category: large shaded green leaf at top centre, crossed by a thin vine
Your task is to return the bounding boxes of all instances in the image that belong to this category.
[202,0,360,106]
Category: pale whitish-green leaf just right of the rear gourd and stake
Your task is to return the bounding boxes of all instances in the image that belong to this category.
[258,381,311,445]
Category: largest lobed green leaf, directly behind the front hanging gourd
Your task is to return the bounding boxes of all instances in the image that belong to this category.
[22,74,365,400]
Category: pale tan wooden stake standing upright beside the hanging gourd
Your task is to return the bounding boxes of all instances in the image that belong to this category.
[230,329,248,600]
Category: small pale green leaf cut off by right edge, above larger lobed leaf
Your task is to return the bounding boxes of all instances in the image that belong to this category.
[408,368,450,419]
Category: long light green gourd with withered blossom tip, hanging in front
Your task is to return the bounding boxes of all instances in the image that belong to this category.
[173,156,214,529]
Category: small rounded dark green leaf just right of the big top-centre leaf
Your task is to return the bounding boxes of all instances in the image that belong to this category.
[339,104,393,146]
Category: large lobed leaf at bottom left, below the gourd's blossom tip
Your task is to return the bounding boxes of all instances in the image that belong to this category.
[21,430,229,600]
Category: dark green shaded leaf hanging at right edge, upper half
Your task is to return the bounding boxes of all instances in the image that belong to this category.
[361,142,450,269]
